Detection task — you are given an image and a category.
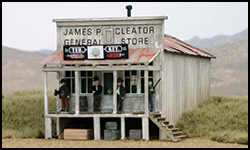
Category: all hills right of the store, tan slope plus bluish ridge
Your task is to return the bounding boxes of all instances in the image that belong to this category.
[185,28,248,95]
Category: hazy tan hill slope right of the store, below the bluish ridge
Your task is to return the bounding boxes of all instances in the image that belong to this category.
[203,39,248,96]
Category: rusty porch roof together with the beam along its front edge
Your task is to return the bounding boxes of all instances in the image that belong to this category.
[41,48,160,71]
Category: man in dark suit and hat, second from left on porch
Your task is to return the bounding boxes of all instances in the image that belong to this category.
[92,76,102,111]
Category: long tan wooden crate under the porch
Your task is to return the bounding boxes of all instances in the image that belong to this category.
[63,129,94,140]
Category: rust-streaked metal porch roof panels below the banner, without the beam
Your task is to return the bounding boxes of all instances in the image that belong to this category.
[41,48,160,64]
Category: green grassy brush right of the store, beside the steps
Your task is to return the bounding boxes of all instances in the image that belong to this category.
[177,96,248,143]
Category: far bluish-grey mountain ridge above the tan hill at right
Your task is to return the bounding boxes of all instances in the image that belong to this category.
[185,28,248,49]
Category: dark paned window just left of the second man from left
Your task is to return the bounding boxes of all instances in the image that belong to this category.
[81,71,93,93]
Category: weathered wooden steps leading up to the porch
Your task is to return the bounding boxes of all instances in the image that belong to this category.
[149,112,187,142]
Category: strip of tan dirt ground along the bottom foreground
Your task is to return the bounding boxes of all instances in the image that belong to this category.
[2,138,248,148]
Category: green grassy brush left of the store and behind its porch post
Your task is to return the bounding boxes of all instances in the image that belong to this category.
[2,90,56,138]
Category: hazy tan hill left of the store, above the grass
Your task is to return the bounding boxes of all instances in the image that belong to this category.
[2,46,56,94]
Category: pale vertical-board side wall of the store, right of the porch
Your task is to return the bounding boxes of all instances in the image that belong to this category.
[162,53,211,124]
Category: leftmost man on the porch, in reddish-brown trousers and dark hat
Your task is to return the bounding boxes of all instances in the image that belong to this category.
[57,79,70,111]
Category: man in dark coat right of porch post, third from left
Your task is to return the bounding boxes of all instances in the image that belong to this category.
[117,78,126,111]
